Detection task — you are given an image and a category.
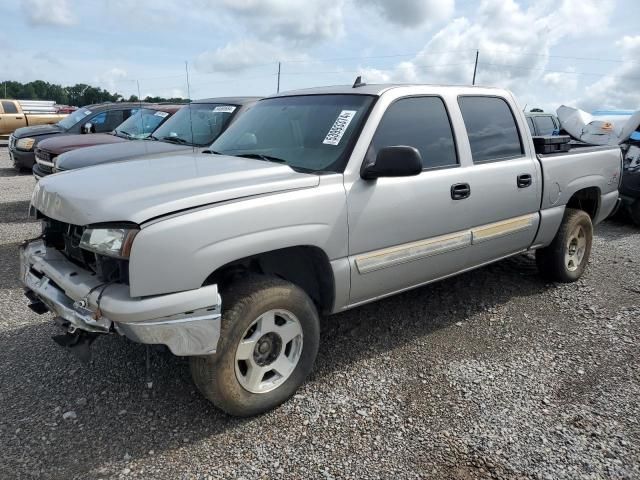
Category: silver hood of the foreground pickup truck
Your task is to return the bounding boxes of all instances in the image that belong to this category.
[31,152,320,225]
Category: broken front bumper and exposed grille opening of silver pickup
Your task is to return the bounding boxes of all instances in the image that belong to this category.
[20,221,221,361]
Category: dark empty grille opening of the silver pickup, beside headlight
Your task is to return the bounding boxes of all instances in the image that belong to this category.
[43,217,129,285]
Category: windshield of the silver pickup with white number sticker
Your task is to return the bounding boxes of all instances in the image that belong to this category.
[211,95,374,171]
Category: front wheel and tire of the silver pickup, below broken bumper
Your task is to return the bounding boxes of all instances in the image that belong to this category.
[190,276,320,417]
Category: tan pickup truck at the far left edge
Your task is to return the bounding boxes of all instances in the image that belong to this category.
[0,99,67,135]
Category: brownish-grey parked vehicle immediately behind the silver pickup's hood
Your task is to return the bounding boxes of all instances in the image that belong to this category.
[53,97,260,172]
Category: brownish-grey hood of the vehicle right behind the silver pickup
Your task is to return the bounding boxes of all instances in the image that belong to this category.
[56,139,192,170]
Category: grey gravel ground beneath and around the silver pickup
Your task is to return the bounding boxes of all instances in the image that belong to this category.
[0,147,640,480]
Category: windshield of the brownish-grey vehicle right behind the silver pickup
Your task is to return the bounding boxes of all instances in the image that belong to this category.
[153,103,240,147]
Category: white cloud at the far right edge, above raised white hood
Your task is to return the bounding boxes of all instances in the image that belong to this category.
[578,35,640,110]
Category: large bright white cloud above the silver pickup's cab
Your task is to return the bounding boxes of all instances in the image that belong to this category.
[356,0,613,96]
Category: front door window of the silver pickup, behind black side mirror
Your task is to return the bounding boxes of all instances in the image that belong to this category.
[369,97,458,168]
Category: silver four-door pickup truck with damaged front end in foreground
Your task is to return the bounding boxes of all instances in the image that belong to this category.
[21,85,621,416]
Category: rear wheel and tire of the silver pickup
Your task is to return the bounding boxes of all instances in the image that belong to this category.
[536,208,593,283]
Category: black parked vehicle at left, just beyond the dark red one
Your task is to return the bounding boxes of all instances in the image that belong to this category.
[9,102,145,171]
